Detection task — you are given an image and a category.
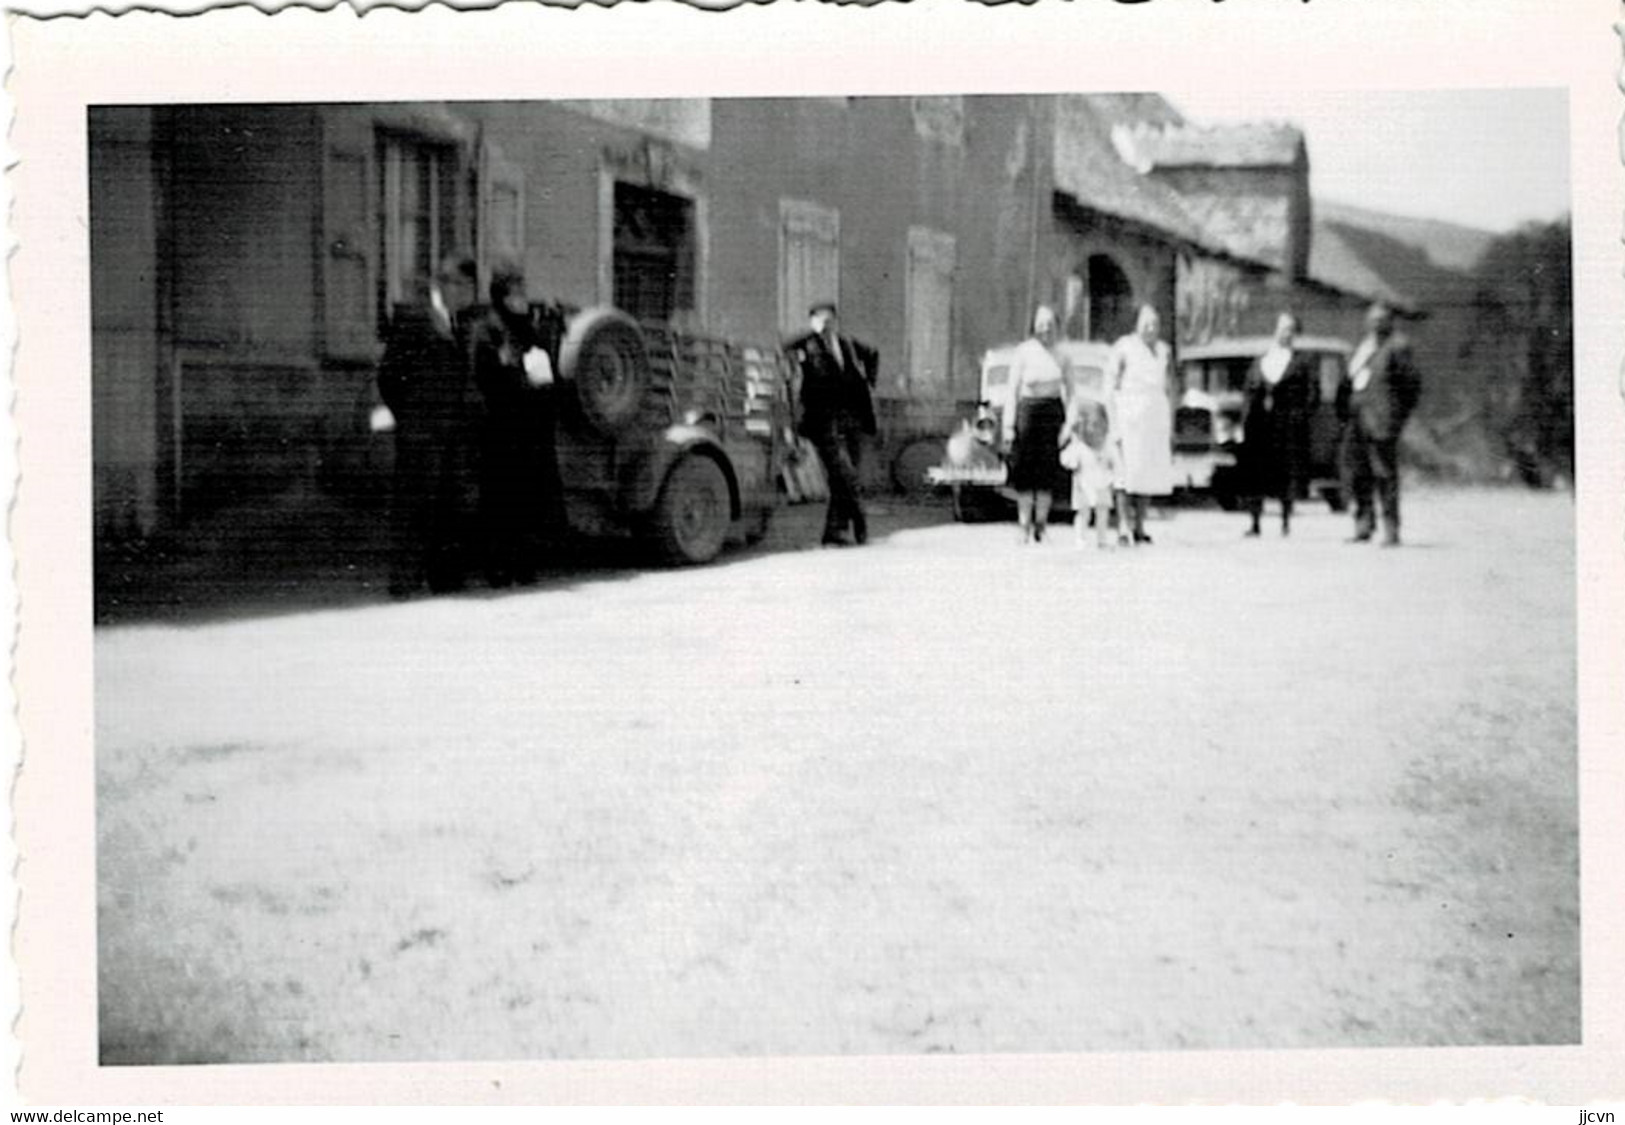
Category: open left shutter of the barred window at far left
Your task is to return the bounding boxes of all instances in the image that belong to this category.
[320,109,379,363]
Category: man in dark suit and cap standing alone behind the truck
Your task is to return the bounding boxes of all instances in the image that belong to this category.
[788,302,879,546]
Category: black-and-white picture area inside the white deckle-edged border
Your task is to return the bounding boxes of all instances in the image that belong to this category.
[3,0,1620,1105]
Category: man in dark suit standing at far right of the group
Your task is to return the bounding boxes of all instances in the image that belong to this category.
[1337,304,1422,546]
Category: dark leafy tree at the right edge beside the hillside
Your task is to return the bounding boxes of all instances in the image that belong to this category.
[1466,219,1575,486]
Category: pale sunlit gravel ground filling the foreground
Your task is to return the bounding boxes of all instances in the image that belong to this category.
[96,489,1580,1063]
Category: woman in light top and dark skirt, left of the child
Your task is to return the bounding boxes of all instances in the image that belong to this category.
[1004,304,1068,543]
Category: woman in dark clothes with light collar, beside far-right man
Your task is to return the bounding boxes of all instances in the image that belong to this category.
[1238,312,1320,535]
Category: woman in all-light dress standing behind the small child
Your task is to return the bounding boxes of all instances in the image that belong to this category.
[1107,304,1173,545]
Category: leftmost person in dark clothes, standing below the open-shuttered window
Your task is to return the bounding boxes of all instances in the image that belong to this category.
[379,257,478,598]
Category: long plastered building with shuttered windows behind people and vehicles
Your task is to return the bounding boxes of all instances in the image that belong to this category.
[89,96,1384,541]
